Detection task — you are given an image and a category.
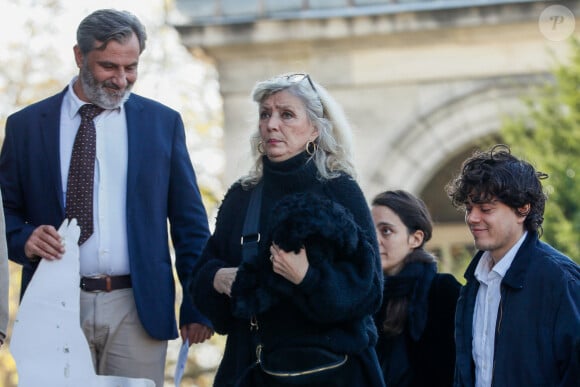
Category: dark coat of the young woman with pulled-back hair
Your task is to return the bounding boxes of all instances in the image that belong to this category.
[375,252,461,387]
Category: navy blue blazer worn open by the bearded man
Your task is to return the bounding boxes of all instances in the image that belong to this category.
[0,89,211,340]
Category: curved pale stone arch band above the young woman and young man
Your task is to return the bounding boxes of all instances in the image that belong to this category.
[368,75,547,199]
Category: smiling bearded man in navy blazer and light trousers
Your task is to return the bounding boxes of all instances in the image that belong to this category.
[0,10,213,386]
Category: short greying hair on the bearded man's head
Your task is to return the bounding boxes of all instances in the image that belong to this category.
[77,9,147,55]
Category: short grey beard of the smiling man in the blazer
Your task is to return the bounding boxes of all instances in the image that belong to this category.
[80,64,133,109]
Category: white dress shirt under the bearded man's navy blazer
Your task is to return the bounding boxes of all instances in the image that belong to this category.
[60,78,130,277]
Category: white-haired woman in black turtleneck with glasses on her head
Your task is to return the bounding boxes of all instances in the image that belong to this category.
[190,74,384,387]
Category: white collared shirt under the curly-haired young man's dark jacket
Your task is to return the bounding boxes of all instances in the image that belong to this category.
[472,232,528,387]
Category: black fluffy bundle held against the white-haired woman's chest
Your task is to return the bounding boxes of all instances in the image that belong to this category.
[232,192,362,317]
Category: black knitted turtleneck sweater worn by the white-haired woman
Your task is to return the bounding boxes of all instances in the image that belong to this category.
[190,153,382,386]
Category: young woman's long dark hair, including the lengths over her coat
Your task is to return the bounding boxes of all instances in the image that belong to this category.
[371,190,435,336]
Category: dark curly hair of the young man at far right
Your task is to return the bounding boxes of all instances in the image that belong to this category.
[445,144,548,234]
